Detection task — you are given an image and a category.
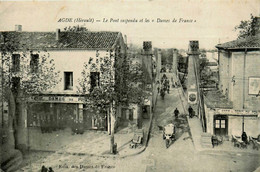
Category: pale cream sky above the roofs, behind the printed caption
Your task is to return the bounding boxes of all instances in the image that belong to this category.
[0,0,260,49]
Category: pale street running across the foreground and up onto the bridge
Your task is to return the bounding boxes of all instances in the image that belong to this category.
[19,73,260,172]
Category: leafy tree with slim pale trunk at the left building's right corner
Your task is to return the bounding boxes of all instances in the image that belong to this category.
[78,49,147,153]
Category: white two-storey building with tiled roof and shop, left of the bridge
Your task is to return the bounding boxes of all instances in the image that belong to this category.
[0,26,127,148]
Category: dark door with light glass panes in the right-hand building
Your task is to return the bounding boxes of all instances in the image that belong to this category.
[214,115,228,136]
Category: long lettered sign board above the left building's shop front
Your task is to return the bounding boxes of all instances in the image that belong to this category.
[29,96,84,103]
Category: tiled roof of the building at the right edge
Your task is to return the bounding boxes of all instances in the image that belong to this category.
[216,35,260,49]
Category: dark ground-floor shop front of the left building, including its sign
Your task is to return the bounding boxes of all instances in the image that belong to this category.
[27,95,107,132]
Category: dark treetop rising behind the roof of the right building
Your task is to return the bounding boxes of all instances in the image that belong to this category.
[235,14,256,39]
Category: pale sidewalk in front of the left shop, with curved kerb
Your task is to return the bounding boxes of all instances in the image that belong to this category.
[26,119,149,158]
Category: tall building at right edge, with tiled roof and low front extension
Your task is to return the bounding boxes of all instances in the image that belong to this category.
[207,17,260,137]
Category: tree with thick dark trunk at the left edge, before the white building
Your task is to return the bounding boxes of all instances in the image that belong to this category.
[0,32,59,149]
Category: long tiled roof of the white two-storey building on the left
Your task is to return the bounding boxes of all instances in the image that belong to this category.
[0,31,120,49]
